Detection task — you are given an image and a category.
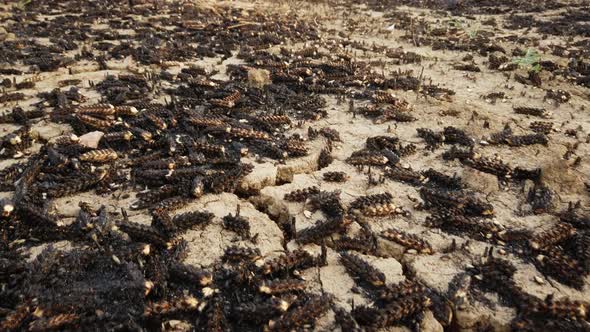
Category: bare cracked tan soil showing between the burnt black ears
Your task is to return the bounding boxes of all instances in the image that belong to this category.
[0,1,590,331]
